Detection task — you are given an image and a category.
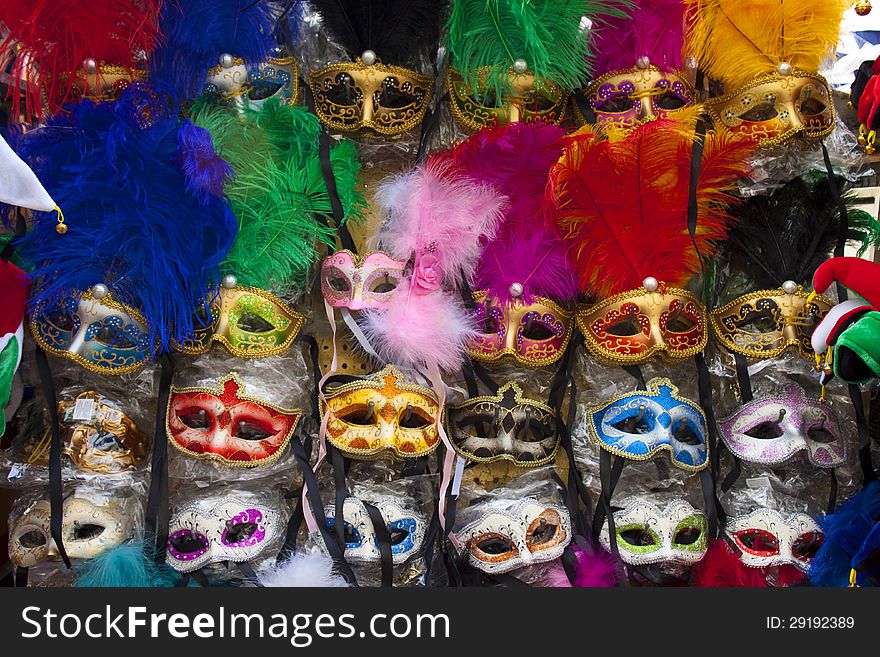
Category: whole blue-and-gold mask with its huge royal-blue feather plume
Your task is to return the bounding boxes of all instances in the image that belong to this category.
[13,82,237,374]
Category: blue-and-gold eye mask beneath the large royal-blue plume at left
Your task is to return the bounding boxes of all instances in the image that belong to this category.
[31,292,153,374]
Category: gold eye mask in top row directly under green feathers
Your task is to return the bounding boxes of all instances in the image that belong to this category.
[446,68,568,131]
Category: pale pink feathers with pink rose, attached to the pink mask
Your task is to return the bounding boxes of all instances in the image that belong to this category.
[361,157,506,372]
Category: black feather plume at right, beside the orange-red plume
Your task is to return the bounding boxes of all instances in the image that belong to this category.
[725,177,876,289]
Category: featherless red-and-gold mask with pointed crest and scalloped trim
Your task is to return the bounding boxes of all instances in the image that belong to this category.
[165,372,302,468]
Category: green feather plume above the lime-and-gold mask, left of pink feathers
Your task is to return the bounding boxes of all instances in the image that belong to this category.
[192,101,365,296]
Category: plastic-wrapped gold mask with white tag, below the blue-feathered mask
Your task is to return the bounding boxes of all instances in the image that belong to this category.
[58,390,148,474]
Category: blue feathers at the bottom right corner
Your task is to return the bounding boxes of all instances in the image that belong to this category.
[810,482,880,586]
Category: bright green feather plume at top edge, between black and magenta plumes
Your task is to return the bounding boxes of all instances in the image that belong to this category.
[446,0,628,96]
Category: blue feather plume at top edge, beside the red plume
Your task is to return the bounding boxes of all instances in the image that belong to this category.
[150,0,277,102]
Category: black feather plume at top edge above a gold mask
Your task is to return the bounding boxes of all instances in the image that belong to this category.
[312,0,445,68]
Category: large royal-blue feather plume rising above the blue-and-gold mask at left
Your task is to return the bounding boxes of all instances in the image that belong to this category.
[13,85,238,351]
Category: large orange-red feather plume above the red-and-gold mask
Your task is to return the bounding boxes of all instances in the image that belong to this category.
[548,119,754,298]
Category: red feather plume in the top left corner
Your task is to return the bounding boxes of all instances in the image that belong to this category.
[0,0,163,116]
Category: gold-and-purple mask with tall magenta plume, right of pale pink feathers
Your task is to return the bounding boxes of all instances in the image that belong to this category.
[448,123,577,366]
